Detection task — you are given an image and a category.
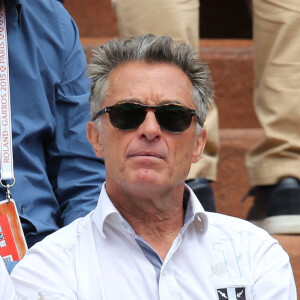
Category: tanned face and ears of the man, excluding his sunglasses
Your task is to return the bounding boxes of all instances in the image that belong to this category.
[88,62,206,195]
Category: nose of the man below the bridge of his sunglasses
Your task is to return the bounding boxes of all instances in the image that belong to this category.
[138,110,161,141]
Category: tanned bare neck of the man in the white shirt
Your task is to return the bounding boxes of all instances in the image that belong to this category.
[107,184,185,259]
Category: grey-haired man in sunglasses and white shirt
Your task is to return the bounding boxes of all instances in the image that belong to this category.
[12,35,296,300]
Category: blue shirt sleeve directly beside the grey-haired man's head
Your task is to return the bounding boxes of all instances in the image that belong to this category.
[47,4,105,226]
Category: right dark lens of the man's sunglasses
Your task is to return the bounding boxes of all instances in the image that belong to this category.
[155,105,192,132]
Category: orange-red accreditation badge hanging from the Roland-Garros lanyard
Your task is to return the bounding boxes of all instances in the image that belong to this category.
[0,199,27,261]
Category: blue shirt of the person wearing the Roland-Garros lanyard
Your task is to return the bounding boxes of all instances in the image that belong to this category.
[0,0,105,247]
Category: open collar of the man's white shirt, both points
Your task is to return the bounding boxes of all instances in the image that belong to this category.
[92,183,208,239]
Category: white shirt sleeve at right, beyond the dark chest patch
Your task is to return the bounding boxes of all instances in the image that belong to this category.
[253,237,297,300]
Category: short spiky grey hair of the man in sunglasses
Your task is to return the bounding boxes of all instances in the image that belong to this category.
[88,34,213,126]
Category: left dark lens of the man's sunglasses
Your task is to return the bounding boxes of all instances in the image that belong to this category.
[109,103,146,130]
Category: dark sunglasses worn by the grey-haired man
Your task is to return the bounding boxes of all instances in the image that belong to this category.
[92,102,201,133]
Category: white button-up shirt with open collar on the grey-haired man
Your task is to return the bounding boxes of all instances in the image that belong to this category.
[12,185,297,300]
